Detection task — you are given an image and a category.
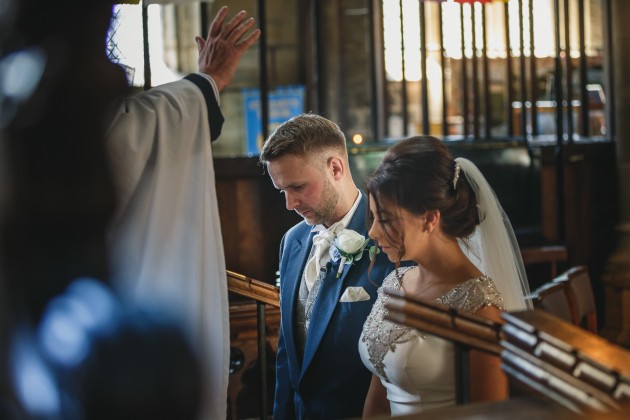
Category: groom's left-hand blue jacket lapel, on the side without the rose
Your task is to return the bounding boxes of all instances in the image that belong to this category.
[281,229,313,376]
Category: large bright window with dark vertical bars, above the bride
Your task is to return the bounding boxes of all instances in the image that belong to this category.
[376,0,610,141]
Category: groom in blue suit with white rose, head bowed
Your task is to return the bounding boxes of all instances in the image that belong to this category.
[260,114,393,419]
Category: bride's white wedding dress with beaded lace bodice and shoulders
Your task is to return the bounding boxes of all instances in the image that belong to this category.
[359,267,504,416]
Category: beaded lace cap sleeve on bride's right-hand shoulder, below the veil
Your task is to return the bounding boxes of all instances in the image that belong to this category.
[438,276,505,313]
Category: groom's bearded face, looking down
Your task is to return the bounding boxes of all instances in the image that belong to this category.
[267,155,339,226]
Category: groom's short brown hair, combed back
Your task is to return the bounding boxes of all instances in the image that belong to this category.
[259,113,347,164]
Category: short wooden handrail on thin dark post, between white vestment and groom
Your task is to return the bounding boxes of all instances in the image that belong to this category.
[227,270,280,419]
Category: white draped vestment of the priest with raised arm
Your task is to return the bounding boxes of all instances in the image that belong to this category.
[107,76,230,419]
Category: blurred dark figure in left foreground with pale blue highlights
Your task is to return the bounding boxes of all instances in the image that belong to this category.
[0,0,201,419]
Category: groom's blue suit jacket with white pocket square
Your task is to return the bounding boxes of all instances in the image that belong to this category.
[274,193,393,419]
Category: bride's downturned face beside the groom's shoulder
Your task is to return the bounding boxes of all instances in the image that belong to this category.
[368,195,426,262]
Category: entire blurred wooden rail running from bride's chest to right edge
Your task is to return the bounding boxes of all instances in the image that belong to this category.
[386,291,630,418]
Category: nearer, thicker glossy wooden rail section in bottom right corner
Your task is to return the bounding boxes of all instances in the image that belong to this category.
[501,310,630,414]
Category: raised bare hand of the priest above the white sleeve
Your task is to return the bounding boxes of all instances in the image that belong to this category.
[195,6,260,91]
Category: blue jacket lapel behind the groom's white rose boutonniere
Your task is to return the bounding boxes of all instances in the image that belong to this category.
[301,193,367,376]
